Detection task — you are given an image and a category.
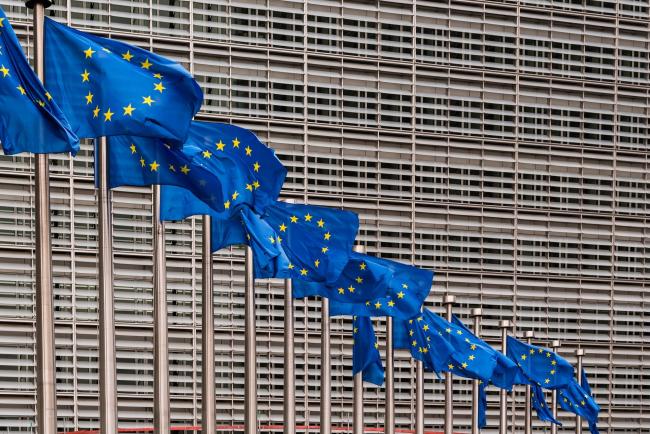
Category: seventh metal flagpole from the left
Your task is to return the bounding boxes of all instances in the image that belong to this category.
[320,297,332,434]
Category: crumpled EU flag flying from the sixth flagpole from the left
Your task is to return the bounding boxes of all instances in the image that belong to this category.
[293,252,392,304]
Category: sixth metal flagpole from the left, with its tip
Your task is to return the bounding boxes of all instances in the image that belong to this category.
[283,199,294,434]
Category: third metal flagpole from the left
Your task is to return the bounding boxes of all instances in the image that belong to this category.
[153,185,170,433]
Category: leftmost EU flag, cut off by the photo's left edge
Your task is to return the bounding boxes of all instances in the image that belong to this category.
[0,8,79,155]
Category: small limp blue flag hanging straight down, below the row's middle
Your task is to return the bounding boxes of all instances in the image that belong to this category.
[352,317,384,386]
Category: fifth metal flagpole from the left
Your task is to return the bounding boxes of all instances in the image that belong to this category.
[244,247,257,434]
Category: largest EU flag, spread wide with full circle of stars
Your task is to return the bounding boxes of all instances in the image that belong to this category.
[45,18,203,144]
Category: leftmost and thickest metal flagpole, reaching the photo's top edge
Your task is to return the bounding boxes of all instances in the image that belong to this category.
[25,0,56,434]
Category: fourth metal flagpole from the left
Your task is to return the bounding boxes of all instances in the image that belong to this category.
[201,214,216,434]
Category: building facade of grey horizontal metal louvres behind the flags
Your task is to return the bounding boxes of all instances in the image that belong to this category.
[0,0,650,433]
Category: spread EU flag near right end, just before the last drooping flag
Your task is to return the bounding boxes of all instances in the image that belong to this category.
[507,336,573,389]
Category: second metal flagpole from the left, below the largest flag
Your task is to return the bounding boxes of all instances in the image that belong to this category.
[95,137,117,434]
